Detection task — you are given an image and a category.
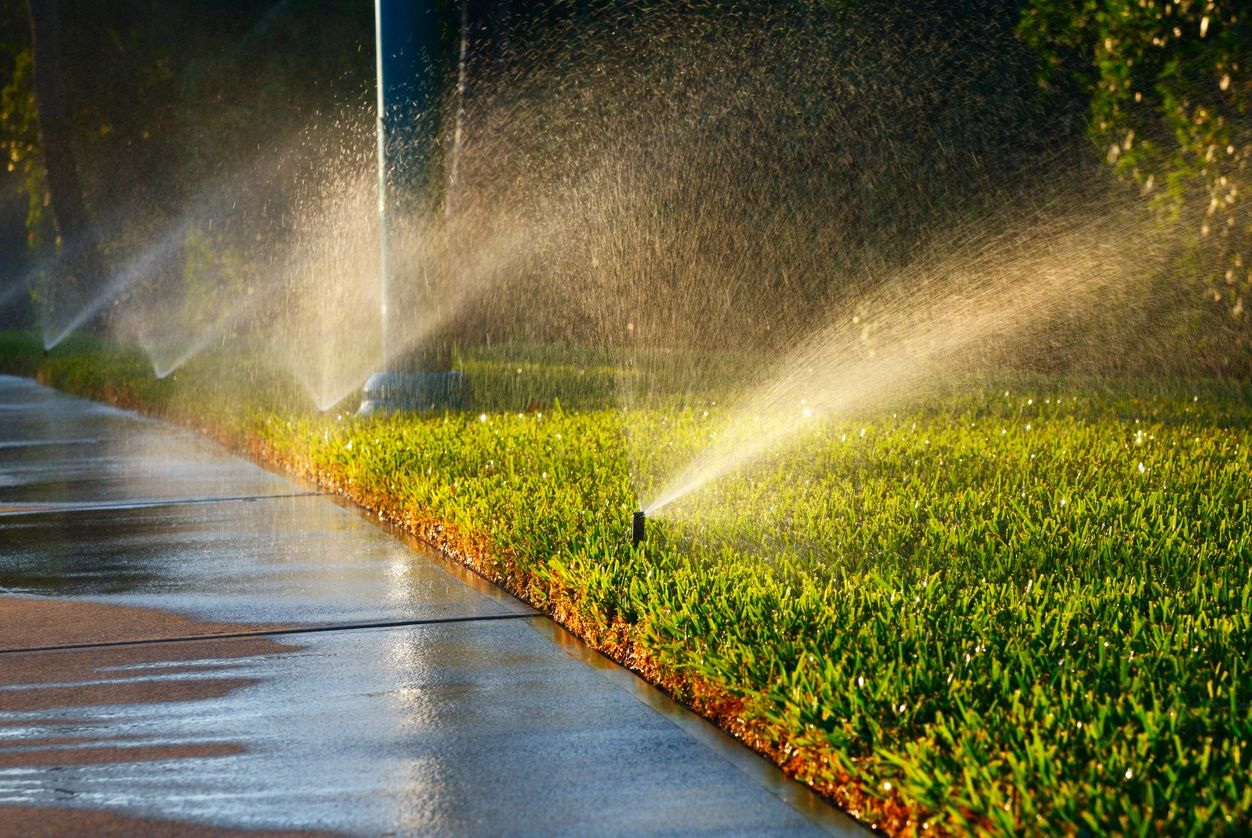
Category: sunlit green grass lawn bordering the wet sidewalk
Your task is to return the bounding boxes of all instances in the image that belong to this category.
[2,330,1252,834]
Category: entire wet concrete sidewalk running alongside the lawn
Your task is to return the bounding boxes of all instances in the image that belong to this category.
[0,377,864,834]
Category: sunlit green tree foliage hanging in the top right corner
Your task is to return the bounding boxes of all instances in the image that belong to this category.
[1019,0,1252,317]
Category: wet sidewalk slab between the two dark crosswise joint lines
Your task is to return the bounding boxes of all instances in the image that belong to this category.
[0,487,530,623]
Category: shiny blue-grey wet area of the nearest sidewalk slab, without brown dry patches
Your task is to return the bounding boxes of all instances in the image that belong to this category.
[0,620,841,834]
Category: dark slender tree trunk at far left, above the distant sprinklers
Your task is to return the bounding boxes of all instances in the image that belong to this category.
[29,0,104,325]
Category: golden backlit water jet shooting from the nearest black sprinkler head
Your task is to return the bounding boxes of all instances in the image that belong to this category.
[644,194,1159,516]
